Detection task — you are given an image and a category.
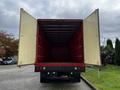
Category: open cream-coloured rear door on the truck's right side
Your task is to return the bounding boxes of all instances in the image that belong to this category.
[83,9,101,65]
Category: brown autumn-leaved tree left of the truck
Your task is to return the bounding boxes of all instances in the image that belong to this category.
[0,31,18,57]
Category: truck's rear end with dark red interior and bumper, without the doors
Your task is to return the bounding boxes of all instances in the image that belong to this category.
[35,19,85,82]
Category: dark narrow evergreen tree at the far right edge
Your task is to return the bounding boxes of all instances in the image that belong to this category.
[115,38,120,65]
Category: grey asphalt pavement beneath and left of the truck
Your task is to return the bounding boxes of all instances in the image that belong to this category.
[0,65,92,90]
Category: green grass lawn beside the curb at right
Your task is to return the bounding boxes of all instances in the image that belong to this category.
[83,65,120,90]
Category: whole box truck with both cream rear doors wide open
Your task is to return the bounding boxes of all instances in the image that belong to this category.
[18,9,101,83]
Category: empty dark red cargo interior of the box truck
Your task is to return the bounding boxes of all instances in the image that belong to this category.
[36,19,84,63]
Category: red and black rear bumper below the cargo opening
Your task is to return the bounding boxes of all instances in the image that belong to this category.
[35,63,85,72]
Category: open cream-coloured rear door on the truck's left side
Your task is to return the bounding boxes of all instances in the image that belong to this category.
[18,9,37,65]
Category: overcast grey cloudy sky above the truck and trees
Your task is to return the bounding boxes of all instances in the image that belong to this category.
[0,0,120,44]
